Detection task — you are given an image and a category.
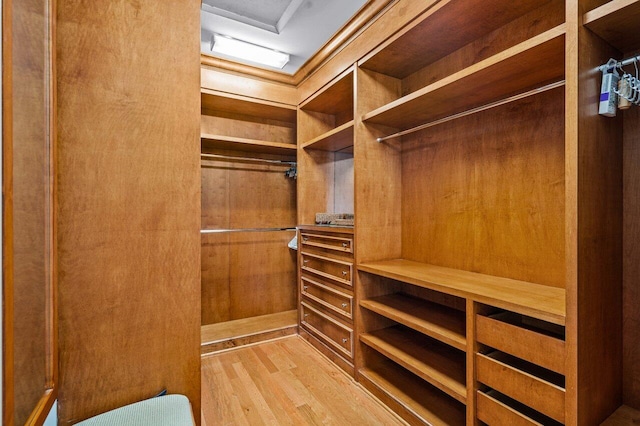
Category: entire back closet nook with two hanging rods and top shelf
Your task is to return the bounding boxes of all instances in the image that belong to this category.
[201,84,296,353]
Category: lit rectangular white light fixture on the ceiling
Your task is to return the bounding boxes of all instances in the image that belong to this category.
[211,34,289,69]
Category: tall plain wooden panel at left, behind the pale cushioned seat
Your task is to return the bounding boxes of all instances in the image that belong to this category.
[57,0,200,424]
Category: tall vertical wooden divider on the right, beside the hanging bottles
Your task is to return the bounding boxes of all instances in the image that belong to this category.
[565,7,623,425]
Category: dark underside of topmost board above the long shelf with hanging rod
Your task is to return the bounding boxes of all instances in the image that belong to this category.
[359,0,552,78]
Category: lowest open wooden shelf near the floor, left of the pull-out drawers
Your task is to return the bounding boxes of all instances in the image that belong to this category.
[359,361,465,426]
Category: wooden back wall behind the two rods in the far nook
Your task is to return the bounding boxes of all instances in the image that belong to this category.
[202,157,296,325]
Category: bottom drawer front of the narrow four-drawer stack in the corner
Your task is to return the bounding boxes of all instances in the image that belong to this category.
[300,302,353,359]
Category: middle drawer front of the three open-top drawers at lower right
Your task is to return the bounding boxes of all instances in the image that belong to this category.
[476,349,565,423]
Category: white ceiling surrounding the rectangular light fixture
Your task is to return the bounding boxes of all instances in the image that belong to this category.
[200,0,367,74]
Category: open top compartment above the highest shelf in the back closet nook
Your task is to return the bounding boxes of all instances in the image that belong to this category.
[200,89,297,124]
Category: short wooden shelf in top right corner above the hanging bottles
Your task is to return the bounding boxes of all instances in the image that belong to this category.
[583,0,640,52]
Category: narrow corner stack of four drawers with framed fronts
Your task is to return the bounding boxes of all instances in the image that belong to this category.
[298,226,354,376]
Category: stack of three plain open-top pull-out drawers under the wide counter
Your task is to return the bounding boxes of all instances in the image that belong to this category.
[475,311,565,425]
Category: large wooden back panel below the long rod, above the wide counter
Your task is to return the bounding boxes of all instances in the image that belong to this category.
[402,89,565,287]
